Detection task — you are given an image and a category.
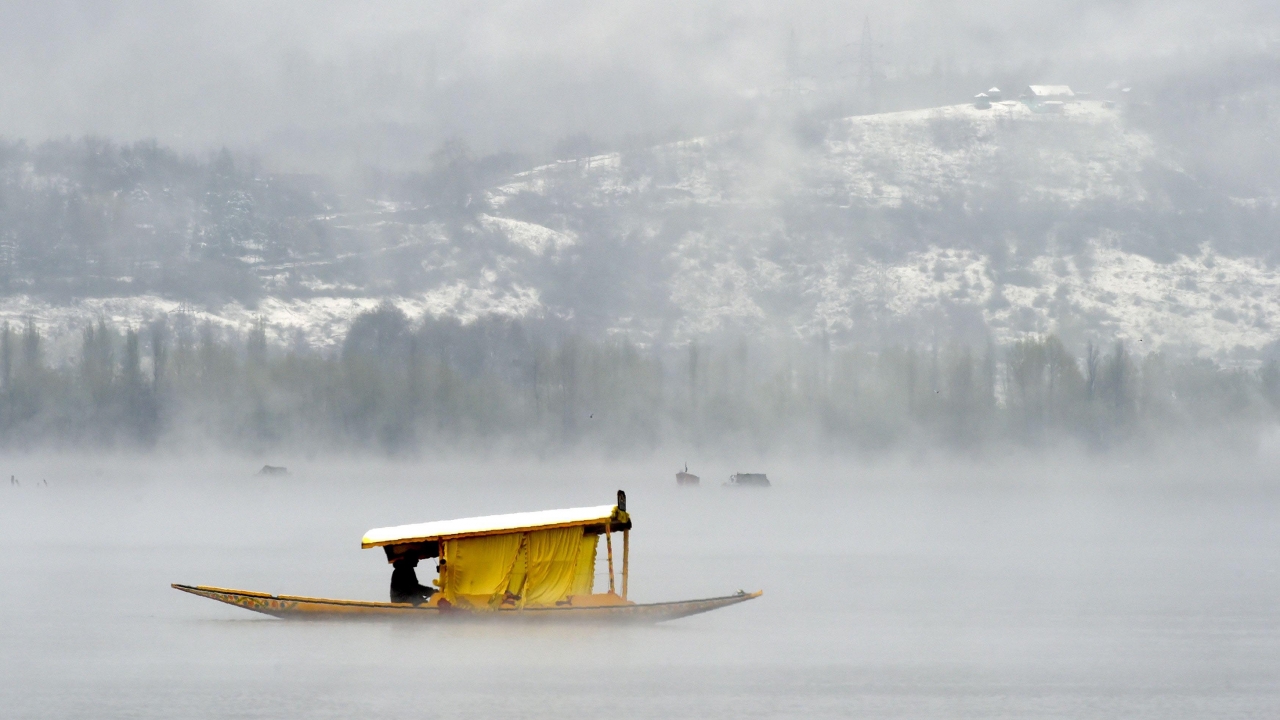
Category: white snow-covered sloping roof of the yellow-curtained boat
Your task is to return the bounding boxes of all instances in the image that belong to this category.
[360,505,628,547]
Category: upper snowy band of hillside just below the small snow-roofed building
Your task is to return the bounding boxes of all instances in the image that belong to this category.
[492,101,1156,208]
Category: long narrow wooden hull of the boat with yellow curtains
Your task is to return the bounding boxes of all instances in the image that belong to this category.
[170,583,763,623]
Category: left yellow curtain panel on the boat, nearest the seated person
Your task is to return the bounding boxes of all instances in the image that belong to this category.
[440,530,519,607]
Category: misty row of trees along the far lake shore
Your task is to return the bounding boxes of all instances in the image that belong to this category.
[0,304,1280,452]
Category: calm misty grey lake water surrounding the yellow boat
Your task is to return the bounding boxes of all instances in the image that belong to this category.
[0,456,1280,719]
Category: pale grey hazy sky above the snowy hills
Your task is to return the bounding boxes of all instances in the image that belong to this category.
[0,0,1280,161]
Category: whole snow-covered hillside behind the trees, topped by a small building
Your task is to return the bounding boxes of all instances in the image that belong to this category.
[0,101,1280,357]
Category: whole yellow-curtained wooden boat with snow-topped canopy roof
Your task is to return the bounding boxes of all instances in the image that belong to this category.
[172,491,762,623]
